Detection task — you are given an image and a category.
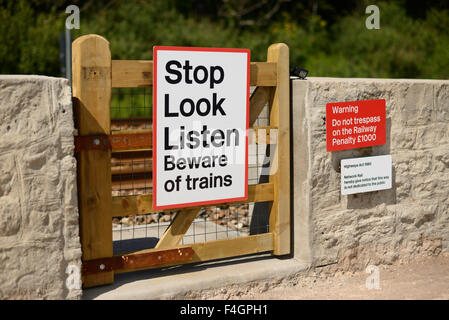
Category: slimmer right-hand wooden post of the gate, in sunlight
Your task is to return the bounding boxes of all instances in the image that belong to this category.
[267,43,290,255]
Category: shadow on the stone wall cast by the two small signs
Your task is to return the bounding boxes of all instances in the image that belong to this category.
[332,118,396,209]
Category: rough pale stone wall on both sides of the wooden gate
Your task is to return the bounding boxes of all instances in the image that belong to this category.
[0,76,449,299]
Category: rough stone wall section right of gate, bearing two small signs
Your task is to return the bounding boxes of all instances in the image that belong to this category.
[292,78,449,270]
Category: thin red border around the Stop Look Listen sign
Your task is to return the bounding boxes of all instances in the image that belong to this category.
[153,46,251,210]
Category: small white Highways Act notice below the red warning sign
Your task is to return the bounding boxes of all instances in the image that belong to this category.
[341,155,392,195]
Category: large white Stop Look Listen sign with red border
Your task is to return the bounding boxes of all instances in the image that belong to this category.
[153,47,250,210]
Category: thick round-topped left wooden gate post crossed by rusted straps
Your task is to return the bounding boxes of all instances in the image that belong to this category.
[72,35,114,287]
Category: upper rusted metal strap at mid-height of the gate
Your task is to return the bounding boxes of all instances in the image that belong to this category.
[75,133,153,152]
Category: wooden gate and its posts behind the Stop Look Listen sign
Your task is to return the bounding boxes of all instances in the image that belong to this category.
[72,35,291,287]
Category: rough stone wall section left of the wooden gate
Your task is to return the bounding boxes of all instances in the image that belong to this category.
[0,76,81,299]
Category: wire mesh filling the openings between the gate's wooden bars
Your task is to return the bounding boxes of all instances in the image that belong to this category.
[111,88,270,254]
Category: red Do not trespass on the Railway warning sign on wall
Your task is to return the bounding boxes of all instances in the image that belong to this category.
[326,99,386,151]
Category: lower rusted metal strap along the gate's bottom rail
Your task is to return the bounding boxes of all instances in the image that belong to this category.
[82,247,194,275]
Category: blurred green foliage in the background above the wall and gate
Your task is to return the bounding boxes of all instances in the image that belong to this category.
[0,0,449,81]
